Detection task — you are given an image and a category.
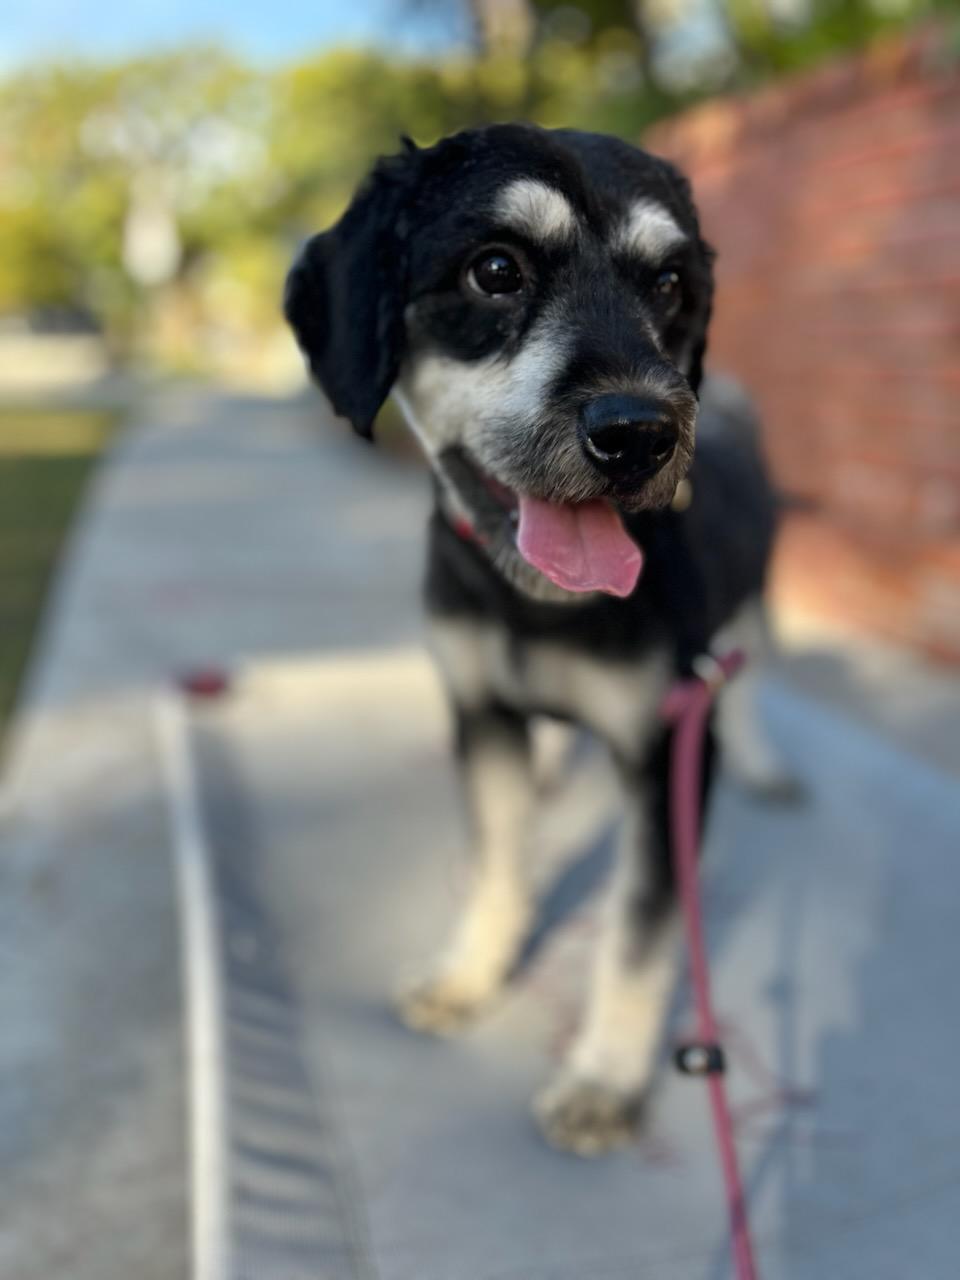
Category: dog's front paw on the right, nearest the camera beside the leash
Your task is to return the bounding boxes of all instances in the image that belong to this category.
[534,1075,644,1156]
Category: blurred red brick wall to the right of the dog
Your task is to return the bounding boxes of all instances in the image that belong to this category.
[646,31,960,660]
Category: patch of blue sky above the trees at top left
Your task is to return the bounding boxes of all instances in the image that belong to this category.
[0,0,466,68]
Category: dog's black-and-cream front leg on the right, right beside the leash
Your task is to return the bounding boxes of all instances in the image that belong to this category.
[535,733,701,1156]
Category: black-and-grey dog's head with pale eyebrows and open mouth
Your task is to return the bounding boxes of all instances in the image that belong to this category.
[285,125,713,599]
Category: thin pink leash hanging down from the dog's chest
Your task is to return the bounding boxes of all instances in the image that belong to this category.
[662,652,756,1280]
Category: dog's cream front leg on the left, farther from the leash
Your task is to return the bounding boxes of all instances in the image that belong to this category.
[399,704,534,1033]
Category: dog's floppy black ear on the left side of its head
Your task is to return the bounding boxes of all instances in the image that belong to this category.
[283,155,415,439]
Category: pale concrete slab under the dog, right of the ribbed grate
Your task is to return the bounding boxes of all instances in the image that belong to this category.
[197,653,960,1280]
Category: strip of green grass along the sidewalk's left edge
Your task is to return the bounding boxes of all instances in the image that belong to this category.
[0,408,118,732]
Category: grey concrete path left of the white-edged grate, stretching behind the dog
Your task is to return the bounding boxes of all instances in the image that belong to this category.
[0,393,426,1280]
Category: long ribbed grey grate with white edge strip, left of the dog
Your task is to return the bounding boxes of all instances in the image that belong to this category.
[159,694,374,1280]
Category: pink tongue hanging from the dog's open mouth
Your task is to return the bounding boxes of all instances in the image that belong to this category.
[517,494,644,595]
